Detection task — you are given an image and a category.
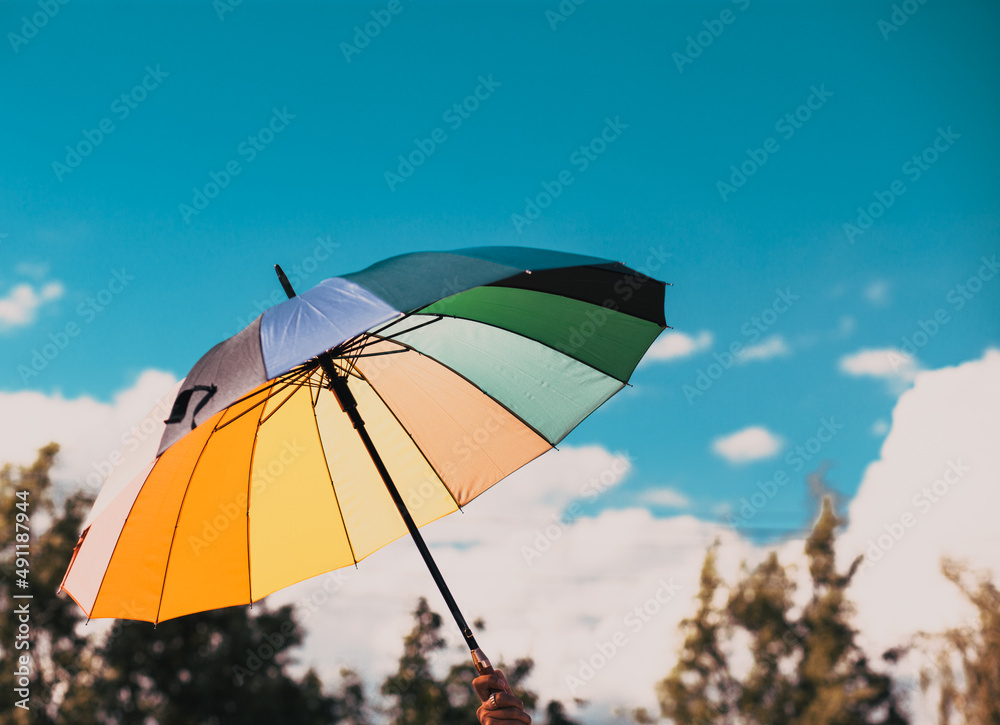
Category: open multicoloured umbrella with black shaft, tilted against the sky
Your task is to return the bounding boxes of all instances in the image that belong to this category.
[62,247,666,671]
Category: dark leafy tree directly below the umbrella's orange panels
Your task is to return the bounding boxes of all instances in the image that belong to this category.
[96,605,339,725]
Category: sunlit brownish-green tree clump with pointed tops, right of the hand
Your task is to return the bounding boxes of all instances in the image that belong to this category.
[657,497,907,725]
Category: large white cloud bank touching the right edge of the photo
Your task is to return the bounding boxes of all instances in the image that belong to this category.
[841,350,1000,647]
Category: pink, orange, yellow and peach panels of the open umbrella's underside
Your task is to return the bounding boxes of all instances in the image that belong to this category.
[63,362,550,622]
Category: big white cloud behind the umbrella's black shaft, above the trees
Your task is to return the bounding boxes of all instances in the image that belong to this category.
[272,478,754,723]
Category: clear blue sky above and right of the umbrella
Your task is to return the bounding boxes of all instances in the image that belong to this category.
[0,0,1000,538]
